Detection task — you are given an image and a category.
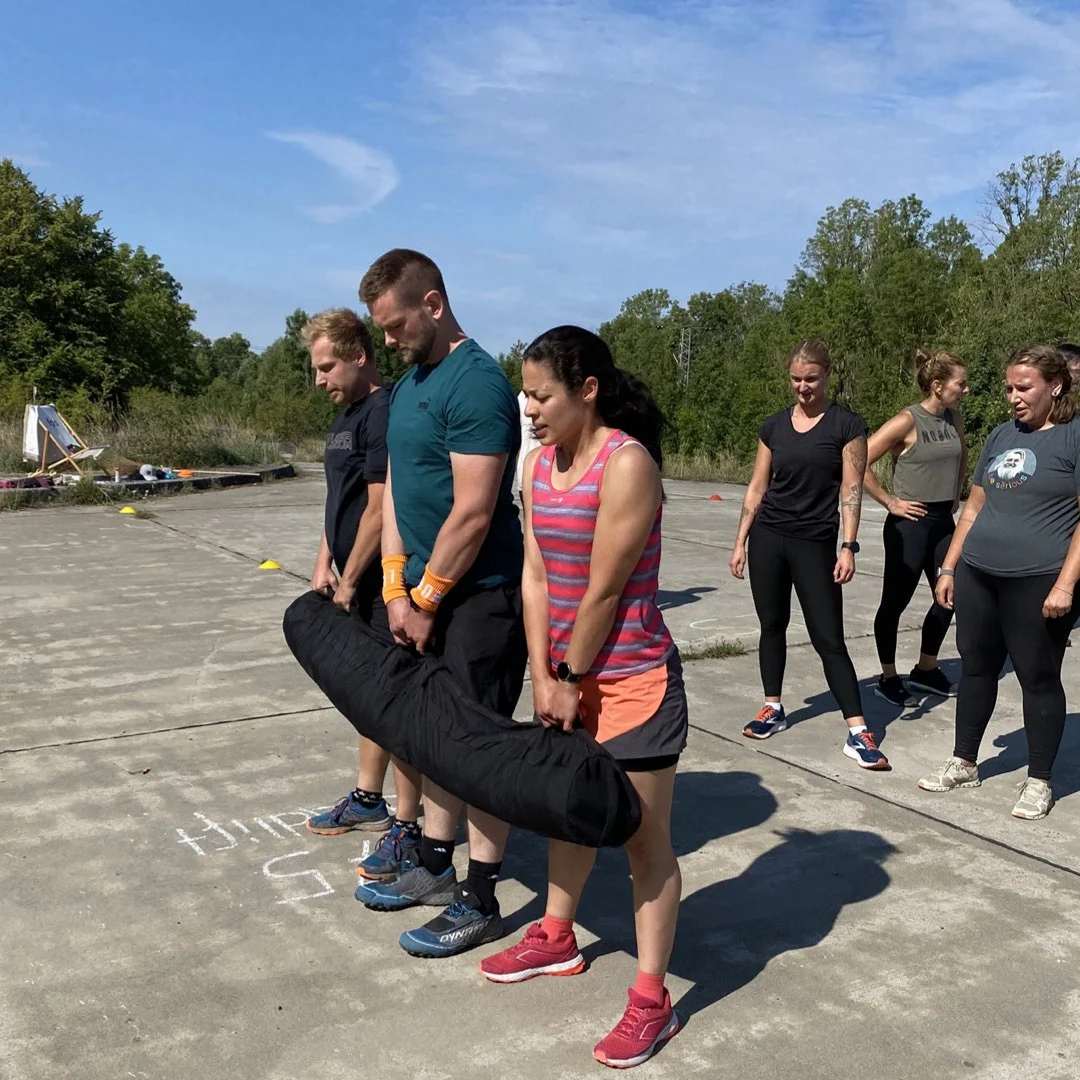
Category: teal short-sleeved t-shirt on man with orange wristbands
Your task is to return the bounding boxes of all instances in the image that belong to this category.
[387,338,525,586]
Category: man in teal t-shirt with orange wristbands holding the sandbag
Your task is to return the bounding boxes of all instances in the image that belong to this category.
[356,248,526,957]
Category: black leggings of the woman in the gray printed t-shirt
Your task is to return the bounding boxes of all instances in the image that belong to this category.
[953,559,1077,781]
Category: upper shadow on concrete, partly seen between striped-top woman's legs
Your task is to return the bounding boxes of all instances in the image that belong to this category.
[502,772,777,941]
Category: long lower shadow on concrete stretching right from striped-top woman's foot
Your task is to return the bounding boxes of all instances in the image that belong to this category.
[669,829,896,1024]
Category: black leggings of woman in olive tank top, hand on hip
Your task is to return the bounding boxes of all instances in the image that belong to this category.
[874,502,955,665]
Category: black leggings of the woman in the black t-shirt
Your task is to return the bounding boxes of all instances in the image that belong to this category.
[748,525,863,719]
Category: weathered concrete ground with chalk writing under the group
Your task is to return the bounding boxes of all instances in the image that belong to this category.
[0,474,1080,1080]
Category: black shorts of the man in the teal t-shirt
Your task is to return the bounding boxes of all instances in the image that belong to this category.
[428,581,528,716]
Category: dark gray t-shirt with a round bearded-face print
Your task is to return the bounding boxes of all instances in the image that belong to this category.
[963,418,1080,578]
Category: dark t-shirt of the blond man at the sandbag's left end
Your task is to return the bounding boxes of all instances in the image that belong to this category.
[323,390,390,596]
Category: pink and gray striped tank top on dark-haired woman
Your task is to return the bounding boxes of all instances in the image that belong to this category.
[532,431,675,680]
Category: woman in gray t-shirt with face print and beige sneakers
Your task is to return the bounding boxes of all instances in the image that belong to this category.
[919,346,1080,820]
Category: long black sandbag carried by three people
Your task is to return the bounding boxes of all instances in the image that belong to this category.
[283,592,642,848]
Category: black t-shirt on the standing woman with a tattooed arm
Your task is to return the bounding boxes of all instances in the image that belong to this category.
[755,405,867,543]
